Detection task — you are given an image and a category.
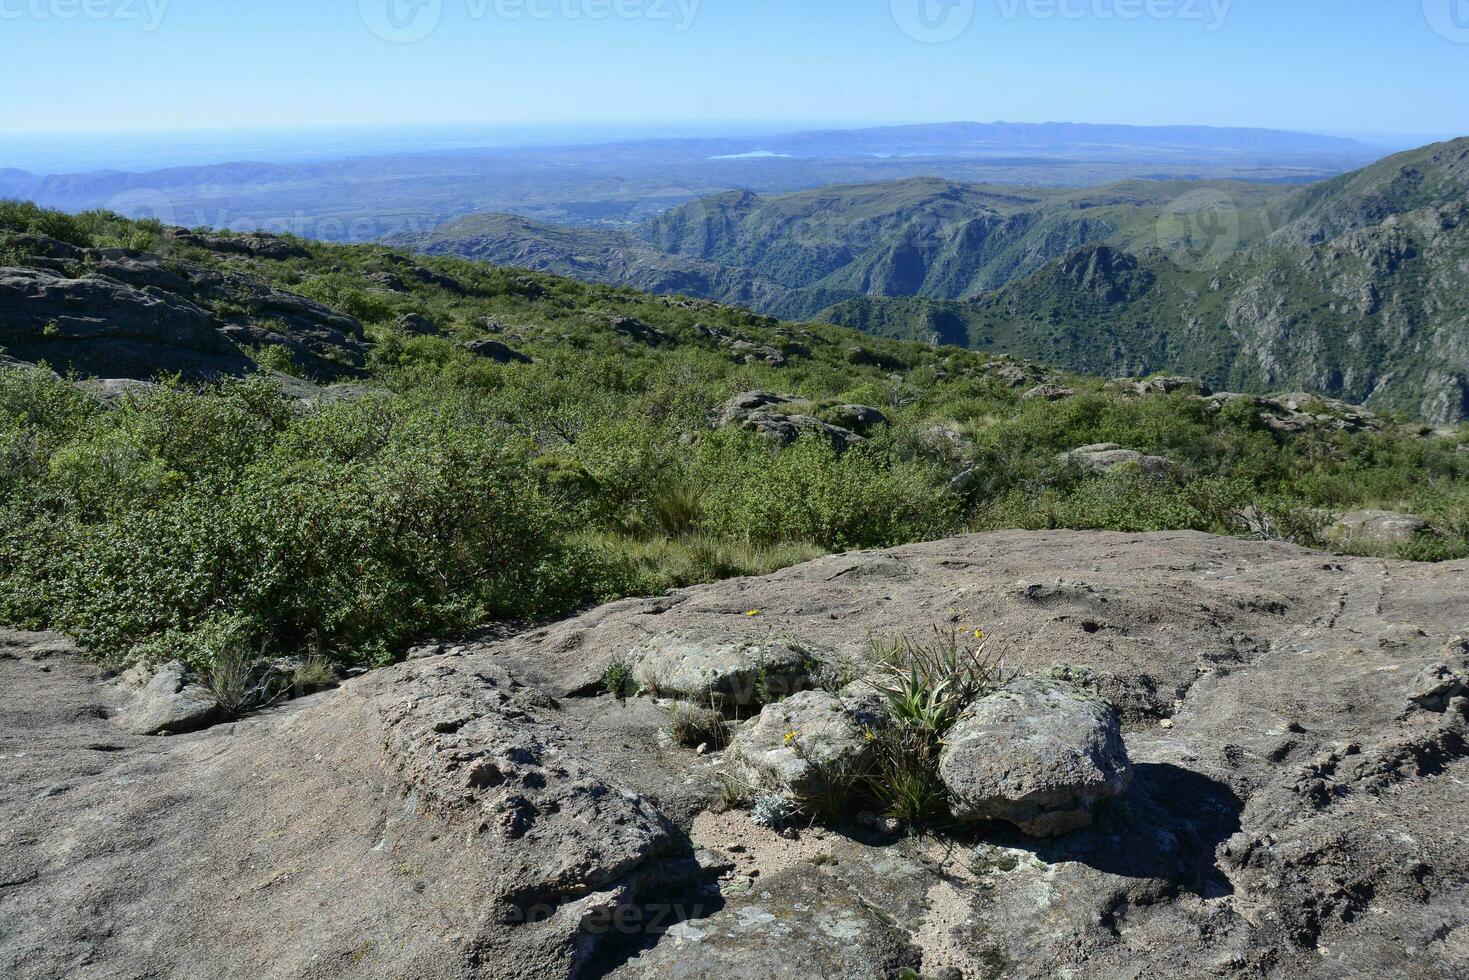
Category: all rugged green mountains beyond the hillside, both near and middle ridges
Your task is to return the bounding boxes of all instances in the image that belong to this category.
[394,137,1469,422]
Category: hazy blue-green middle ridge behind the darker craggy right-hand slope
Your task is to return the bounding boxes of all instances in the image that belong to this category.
[389,178,1287,317]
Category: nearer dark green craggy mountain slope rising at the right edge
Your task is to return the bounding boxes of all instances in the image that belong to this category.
[823,140,1469,422]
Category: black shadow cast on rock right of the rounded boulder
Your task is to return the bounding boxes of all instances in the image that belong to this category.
[989,763,1244,898]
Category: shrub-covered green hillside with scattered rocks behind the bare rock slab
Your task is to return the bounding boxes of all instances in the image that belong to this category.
[0,203,1469,663]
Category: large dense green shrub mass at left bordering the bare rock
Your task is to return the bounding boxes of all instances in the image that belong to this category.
[12,376,607,661]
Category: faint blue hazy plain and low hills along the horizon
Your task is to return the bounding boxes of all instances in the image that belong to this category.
[0,123,1379,241]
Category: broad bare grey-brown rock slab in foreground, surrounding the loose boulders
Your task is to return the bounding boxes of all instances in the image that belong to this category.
[0,532,1469,980]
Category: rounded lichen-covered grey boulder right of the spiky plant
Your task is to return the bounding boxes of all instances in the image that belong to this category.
[939,679,1133,837]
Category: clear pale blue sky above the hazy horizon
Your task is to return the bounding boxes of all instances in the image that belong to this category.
[0,0,1469,135]
